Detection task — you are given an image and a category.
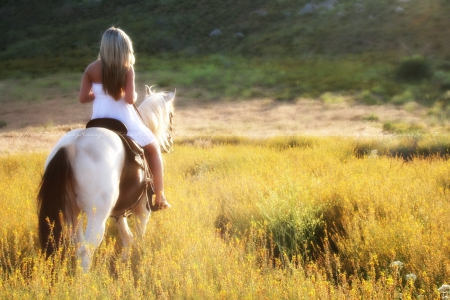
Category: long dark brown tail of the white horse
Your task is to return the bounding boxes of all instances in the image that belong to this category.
[38,147,73,256]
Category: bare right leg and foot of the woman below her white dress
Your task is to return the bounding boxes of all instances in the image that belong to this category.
[143,142,170,208]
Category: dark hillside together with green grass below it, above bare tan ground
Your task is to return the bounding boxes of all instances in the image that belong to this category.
[0,0,450,105]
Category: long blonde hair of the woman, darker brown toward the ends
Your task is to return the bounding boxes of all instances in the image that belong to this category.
[98,27,135,100]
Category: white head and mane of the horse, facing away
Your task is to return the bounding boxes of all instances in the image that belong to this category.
[138,85,176,152]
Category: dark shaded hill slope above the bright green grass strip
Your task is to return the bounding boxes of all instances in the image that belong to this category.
[0,0,450,60]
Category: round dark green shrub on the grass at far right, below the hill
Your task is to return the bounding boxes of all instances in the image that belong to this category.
[396,55,432,81]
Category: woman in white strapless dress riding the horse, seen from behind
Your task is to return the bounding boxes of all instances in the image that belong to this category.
[79,27,170,209]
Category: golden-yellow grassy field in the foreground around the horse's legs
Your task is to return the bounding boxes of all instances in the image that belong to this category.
[0,137,450,299]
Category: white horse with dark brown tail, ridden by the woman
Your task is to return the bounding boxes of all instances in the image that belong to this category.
[38,86,176,272]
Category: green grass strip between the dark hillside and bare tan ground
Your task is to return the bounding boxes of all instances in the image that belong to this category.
[0,54,449,106]
